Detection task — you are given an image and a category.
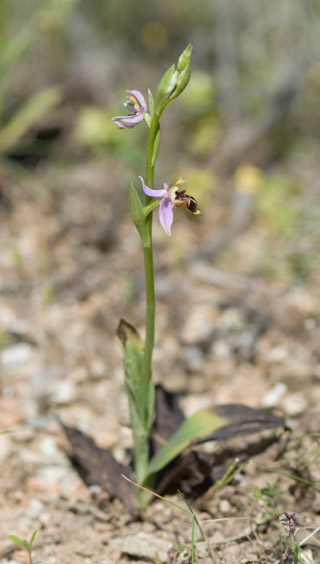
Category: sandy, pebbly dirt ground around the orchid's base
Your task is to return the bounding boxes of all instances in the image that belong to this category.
[0,139,320,564]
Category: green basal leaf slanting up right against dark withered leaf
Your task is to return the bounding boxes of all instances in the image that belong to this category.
[146,409,227,477]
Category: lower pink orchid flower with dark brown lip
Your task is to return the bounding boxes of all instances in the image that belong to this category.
[139,176,200,235]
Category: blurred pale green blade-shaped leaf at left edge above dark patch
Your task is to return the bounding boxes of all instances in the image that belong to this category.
[0,86,62,152]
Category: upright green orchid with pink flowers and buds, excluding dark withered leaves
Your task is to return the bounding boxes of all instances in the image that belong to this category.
[113,45,228,505]
